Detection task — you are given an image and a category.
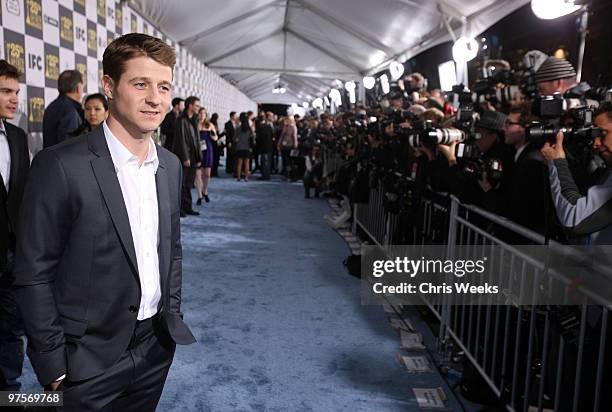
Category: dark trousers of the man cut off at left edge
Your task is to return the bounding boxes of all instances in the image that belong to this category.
[0,279,25,391]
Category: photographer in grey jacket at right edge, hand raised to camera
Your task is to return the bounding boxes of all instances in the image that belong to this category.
[541,102,612,245]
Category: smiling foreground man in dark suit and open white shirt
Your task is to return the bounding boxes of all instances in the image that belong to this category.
[15,33,195,412]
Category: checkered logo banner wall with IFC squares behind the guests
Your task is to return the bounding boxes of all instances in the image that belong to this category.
[0,0,257,153]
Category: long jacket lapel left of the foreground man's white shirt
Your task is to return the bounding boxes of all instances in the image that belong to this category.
[87,127,138,276]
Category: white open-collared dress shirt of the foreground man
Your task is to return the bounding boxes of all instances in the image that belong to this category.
[103,122,161,320]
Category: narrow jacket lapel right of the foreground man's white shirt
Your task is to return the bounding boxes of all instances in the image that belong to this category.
[155,157,171,293]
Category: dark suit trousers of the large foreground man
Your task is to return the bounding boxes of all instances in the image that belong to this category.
[57,316,176,412]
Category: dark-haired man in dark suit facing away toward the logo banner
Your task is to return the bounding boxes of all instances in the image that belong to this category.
[43,70,84,148]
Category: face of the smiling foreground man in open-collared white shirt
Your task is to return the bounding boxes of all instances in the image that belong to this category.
[103,57,172,138]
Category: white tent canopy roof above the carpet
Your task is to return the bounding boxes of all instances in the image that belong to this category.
[130,0,529,104]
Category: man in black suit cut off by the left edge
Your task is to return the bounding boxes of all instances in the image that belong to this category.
[0,60,30,391]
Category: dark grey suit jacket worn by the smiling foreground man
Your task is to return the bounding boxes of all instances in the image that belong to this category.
[15,127,195,385]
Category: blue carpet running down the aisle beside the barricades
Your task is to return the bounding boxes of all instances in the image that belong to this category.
[19,172,417,412]
